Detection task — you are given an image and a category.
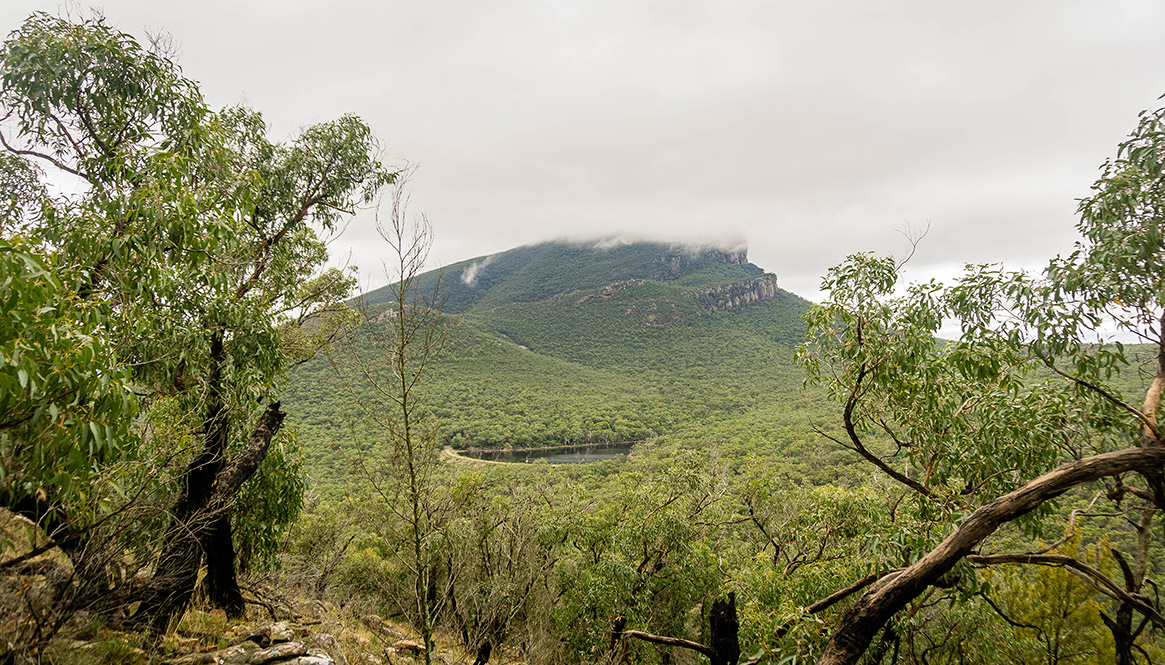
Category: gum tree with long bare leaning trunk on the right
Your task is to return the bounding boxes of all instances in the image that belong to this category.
[802,101,1165,663]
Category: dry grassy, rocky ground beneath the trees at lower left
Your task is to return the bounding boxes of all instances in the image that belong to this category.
[0,510,496,665]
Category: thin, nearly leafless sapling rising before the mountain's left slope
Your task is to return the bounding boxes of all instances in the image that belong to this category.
[331,174,453,665]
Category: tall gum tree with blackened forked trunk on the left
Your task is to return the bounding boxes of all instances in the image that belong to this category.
[0,14,393,629]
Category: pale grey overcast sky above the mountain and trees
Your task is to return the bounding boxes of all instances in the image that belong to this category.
[0,0,1165,299]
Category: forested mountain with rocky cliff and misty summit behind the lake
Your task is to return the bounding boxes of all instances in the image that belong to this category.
[284,241,845,493]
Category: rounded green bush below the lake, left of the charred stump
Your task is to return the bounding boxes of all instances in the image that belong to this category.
[555,451,729,663]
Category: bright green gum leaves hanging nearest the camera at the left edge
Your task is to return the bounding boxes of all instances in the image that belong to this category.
[0,238,137,531]
